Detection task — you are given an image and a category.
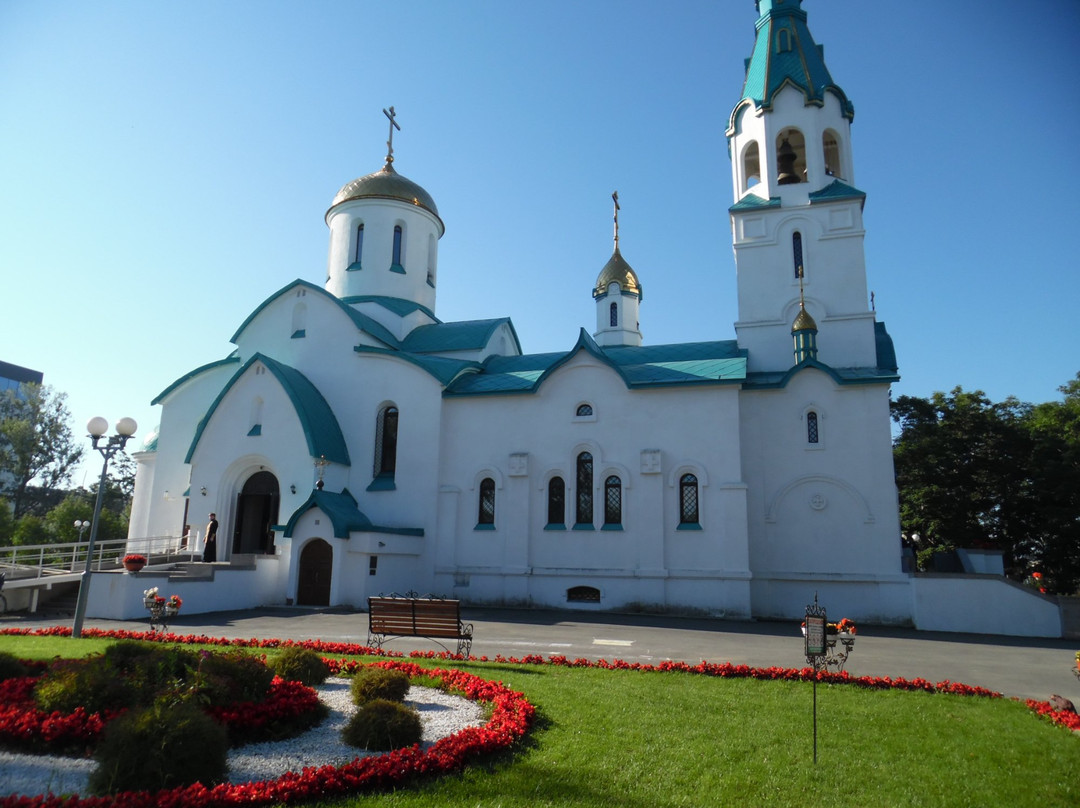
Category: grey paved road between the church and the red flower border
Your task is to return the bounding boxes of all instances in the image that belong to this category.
[0,608,1080,704]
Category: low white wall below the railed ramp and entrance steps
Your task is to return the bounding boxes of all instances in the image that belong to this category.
[86,555,285,620]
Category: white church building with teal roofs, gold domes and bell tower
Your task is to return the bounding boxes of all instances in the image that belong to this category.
[107,0,1061,636]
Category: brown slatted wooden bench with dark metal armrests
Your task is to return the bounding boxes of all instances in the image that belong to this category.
[367,595,472,657]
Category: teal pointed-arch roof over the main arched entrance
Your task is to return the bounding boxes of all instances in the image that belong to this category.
[184,353,350,466]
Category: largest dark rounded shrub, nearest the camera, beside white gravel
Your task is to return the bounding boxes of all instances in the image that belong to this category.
[90,700,229,795]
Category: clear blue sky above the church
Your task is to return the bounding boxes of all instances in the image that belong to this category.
[0,0,1080,483]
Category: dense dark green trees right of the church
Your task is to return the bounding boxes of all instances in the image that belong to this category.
[892,375,1080,594]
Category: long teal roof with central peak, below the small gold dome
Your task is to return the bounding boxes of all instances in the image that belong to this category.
[444,328,746,396]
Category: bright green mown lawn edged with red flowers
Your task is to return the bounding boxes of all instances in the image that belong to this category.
[0,637,1080,808]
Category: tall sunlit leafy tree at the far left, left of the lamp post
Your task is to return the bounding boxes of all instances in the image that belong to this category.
[0,385,82,519]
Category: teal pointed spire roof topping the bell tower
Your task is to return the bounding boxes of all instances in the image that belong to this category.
[729,0,855,123]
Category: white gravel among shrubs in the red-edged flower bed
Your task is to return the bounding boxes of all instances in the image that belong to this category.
[0,678,484,796]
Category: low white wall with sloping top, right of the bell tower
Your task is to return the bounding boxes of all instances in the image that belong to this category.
[912,573,1062,637]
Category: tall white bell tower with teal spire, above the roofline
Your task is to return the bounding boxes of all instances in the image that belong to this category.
[727,0,877,371]
